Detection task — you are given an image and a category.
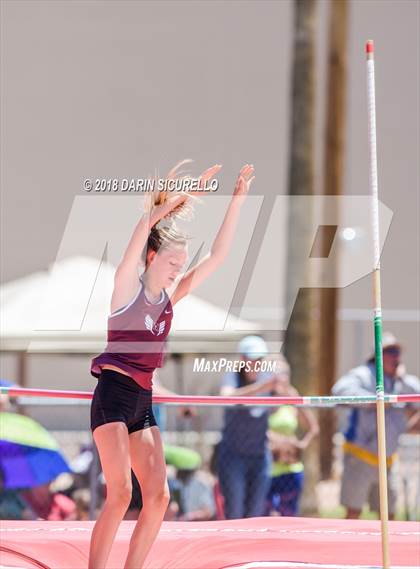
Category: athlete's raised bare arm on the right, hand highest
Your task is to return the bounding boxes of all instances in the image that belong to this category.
[171,164,254,304]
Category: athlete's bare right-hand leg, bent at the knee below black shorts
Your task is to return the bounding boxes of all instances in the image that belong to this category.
[124,427,169,569]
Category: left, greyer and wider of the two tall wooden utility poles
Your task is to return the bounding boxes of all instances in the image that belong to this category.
[284,0,319,513]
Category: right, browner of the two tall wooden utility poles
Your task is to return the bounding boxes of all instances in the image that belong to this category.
[318,0,348,479]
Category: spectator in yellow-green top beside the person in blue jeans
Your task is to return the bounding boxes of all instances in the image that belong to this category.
[266,357,319,516]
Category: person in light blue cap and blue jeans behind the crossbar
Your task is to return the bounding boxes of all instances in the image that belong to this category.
[217,336,277,519]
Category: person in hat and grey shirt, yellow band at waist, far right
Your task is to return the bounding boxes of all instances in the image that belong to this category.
[332,332,420,519]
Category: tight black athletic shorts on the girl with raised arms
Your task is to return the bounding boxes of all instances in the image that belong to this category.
[90,369,157,433]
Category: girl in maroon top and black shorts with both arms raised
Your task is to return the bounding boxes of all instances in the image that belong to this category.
[89,161,254,569]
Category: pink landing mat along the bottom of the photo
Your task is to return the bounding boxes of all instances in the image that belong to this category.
[0,517,420,569]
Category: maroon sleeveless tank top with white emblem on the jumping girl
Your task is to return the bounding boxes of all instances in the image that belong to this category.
[90,278,173,389]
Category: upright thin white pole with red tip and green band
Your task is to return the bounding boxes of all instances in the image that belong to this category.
[366,40,390,569]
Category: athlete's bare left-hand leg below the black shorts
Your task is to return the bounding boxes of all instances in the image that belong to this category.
[88,422,131,569]
